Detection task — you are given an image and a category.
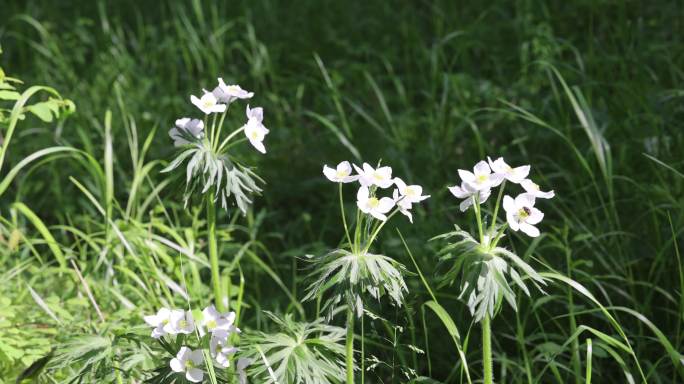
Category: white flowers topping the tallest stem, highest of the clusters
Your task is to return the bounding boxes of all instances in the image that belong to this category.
[169,78,269,153]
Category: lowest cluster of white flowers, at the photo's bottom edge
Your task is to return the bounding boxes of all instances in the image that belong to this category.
[144,305,249,383]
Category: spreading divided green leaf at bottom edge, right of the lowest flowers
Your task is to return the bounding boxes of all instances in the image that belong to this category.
[243,312,345,384]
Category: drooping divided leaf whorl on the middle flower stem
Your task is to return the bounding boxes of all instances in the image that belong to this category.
[304,249,408,318]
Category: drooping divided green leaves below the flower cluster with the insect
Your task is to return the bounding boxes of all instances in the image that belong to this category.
[433,226,546,322]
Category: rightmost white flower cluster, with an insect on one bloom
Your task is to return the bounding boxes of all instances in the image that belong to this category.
[449,157,555,237]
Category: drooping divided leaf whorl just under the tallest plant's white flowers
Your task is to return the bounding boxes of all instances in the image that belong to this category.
[162,142,264,214]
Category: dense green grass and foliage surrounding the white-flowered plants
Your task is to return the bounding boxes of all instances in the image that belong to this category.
[0,0,684,383]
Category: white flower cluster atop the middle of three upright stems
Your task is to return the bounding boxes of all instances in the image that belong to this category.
[323,161,430,223]
